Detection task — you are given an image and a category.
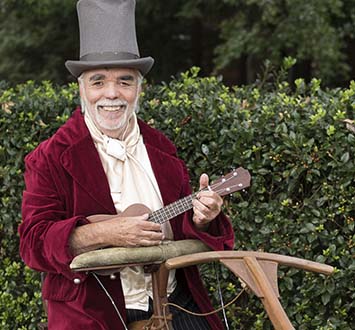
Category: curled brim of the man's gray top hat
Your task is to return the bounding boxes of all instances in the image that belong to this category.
[65,57,154,78]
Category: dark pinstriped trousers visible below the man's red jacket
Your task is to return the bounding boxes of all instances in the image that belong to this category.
[126,284,210,330]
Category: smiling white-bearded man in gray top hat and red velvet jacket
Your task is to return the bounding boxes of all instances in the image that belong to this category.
[19,0,234,330]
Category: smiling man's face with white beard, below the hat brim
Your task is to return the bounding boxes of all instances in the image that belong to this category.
[80,68,140,138]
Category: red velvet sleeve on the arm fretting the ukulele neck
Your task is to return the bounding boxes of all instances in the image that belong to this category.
[182,162,238,251]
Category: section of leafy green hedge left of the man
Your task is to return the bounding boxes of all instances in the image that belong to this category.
[0,81,76,330]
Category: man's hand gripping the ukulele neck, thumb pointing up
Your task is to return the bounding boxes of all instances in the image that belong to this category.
[192,174,223,231]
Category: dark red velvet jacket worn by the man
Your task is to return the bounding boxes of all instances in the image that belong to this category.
[19,109,234,330]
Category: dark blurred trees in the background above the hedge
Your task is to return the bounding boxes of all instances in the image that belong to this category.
[0,0,355,87]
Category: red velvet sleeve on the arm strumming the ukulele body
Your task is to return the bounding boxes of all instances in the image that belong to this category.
[19,149,87,279]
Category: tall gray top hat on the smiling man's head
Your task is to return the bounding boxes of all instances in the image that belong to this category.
[65,0,154,77]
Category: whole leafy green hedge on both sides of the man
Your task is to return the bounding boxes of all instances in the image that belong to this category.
[0,68,355,329]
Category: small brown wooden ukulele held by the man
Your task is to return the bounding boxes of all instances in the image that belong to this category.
[87,167,250,224]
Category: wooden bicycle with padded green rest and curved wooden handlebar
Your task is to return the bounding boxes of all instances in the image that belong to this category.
[70,240,334,330]
